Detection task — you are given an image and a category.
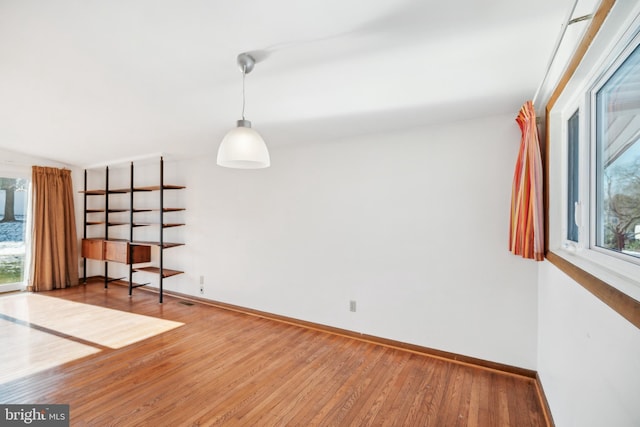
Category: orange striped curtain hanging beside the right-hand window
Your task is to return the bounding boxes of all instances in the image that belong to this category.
[509,101,544,261]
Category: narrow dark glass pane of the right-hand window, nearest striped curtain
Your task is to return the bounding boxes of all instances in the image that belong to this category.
[566,111,580,242]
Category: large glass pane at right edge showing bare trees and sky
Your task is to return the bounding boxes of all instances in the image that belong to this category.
[596,47,640,258]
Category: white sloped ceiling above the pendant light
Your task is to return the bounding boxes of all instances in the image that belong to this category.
[0,0,571,166]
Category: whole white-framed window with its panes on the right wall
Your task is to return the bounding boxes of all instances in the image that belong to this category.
[546,2,640,301]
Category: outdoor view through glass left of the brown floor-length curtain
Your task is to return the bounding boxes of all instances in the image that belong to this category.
[0,178,28,284]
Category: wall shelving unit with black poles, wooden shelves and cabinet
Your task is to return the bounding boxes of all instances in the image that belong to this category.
[82,157,185,303]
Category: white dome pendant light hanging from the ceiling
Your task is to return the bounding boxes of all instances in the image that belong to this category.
[218,53,271,169]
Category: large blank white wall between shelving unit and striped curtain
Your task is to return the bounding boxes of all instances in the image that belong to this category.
[131,113,537,368]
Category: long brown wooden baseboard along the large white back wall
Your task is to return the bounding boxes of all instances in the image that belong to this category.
[87,276,537,380]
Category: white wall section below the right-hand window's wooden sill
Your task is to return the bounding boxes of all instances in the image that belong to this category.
[538,262,640,427]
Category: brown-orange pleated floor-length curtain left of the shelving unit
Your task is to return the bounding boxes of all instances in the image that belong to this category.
[29,166,79,292]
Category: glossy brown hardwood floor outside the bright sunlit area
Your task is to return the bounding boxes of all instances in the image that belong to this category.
[0,284,546,427]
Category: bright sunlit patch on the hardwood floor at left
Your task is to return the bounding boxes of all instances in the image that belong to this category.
[0,292,184,384]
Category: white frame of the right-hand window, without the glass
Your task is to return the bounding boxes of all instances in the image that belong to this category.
[548,2,640,300]
